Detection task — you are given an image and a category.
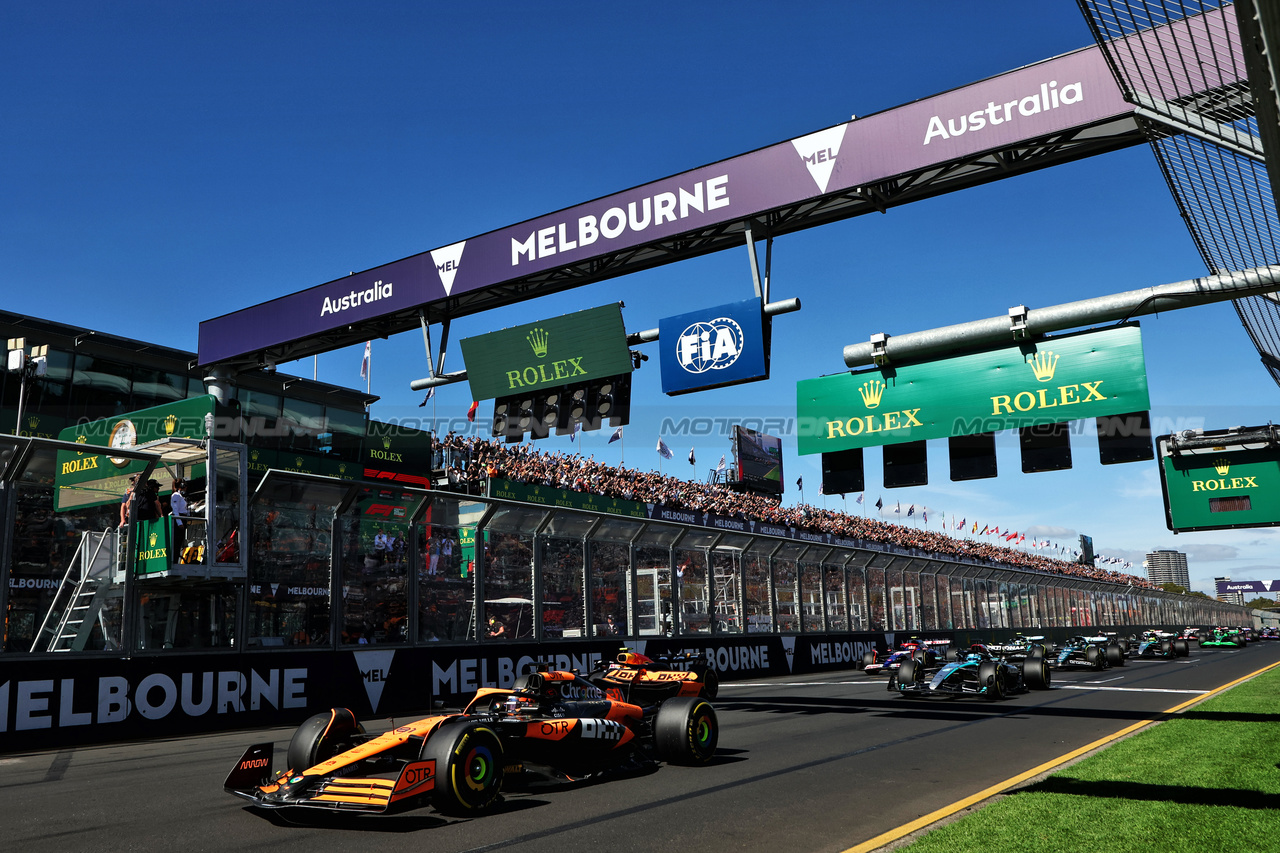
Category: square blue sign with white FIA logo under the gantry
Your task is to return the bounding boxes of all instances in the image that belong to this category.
[658,300,769,396]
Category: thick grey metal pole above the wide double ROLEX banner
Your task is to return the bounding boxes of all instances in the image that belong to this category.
[844,265,1280,368]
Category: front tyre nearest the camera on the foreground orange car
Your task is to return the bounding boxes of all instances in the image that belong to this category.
[419,720,503,815]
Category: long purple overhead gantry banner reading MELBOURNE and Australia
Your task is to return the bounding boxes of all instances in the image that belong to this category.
[200,49,1132,365]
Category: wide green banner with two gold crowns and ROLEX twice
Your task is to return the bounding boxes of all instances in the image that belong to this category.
[796,325,1151,455]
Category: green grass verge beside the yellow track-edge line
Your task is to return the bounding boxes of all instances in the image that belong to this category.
[902,669,1280,853]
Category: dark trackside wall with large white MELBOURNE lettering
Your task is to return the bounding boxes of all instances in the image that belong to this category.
[0,626,1174,753]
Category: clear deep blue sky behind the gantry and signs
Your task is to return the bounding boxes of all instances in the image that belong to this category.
[0,0,1280,592]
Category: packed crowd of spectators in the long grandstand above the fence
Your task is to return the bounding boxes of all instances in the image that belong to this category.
[436,433,1156,589]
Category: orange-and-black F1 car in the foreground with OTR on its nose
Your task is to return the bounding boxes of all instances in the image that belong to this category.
[223,671,719,815]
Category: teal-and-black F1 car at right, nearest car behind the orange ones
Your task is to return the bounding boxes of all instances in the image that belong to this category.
[891,643,1051,701]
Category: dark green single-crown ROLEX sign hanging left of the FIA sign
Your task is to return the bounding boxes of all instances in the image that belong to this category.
[462,304,631,400]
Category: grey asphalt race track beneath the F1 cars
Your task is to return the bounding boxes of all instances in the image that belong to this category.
[0,642,1280,853]
